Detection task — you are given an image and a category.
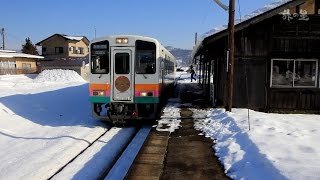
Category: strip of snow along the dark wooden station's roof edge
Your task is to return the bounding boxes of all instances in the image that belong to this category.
[192,0,293,57]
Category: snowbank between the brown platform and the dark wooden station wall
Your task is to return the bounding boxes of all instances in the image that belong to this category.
[195,109,320,179]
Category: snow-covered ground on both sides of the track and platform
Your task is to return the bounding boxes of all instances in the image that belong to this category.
[0,70,320,179]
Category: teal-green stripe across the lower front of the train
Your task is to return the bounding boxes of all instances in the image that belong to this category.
[89,96,159,104]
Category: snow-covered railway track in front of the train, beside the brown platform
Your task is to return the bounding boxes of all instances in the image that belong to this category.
[49,125,151,179]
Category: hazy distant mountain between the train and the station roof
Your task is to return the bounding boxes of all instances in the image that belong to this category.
[166,46,192,66]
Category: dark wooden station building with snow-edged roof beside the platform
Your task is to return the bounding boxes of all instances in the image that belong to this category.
[193,0,320,113]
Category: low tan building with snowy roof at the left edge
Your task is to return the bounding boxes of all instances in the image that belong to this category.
[0,50,44,75]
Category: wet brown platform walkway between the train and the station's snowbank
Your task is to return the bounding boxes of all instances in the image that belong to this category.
[125,84,230,180]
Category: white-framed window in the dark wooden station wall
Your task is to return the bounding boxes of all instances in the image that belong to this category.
[270,59,318,87]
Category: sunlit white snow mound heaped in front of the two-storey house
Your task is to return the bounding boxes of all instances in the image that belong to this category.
[34,69,86,82]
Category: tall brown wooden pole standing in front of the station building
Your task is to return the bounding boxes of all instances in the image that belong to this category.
[226,0,235,112]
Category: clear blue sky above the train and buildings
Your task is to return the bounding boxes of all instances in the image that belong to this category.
[0,0,273,50]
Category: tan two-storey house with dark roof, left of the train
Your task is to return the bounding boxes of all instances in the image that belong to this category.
[36,34,90,79]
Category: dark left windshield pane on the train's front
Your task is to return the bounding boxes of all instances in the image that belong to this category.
[91,41,110,74]
